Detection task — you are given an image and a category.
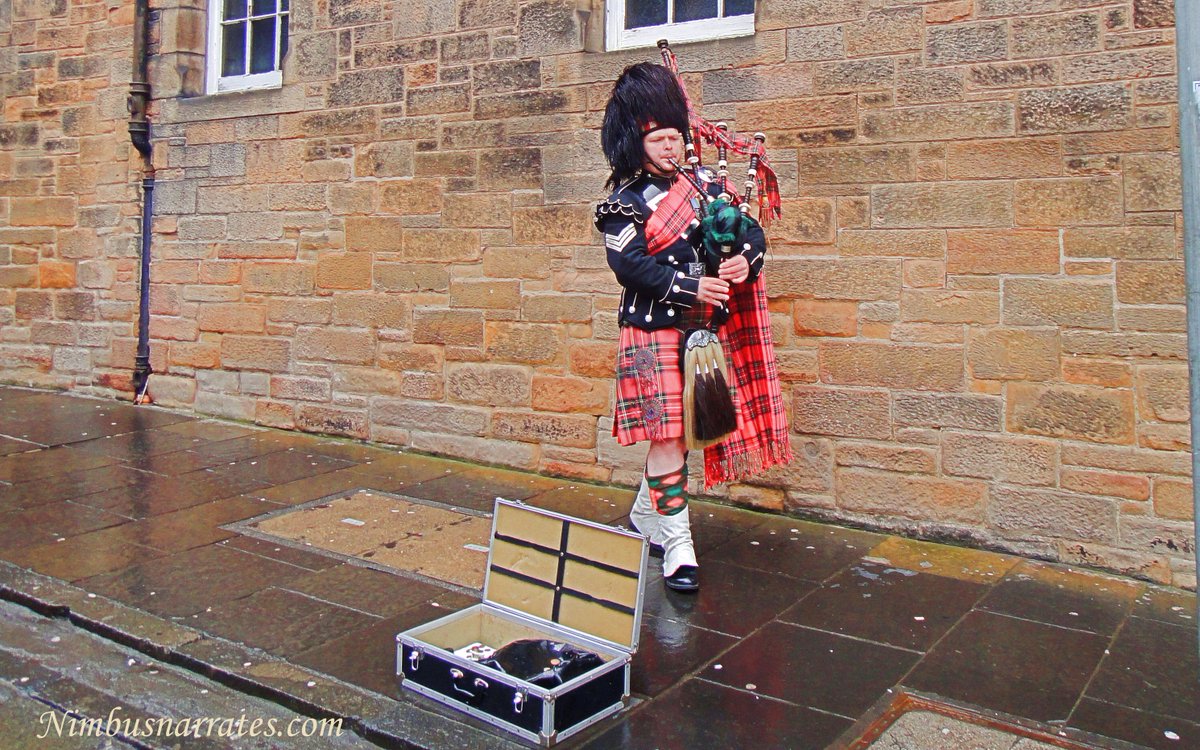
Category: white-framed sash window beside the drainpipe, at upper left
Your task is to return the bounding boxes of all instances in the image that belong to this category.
[206,0,290,94]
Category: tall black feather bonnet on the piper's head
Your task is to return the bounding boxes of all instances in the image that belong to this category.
[600,62,688,187]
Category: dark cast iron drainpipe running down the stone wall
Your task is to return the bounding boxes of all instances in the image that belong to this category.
[128,0,154,403]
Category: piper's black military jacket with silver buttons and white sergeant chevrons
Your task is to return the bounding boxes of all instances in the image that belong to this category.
[595,172,767,330]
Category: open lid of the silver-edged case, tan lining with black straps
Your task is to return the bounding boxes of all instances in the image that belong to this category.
[484,498,649,652]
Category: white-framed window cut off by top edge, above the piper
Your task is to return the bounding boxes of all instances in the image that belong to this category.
[605,0,755,50]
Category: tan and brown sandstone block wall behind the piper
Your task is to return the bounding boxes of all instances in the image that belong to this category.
[0,0,1195,586]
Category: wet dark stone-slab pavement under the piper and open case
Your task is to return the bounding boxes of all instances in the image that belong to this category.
[0,386,1200,750]
